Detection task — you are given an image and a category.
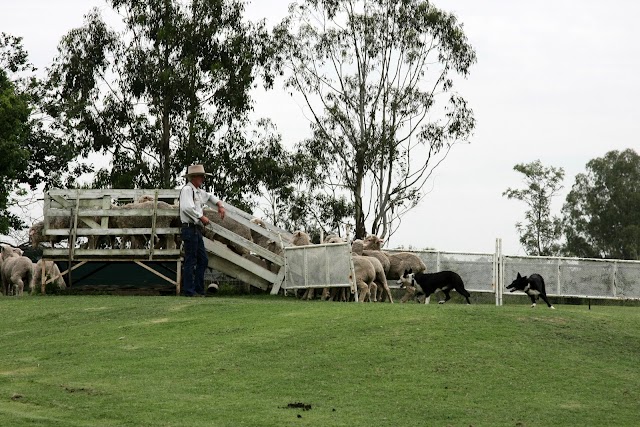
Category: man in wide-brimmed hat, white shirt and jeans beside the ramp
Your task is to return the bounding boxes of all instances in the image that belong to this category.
[180,165,225,297]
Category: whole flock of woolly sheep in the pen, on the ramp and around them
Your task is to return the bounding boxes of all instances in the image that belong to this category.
[0,196,426,302]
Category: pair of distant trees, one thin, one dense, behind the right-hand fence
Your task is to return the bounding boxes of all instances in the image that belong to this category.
[503,149,640,260]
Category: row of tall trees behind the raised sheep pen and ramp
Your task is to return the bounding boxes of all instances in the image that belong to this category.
[0,0,476,242]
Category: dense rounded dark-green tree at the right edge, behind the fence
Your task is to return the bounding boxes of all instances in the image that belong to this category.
[562,149,640,259]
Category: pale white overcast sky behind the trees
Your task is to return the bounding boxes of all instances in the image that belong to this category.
[0,0,640,255]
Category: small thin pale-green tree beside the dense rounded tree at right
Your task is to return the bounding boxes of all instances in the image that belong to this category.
[502,160,564,256]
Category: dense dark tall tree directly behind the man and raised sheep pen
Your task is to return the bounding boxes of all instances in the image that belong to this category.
[48,0,282,196]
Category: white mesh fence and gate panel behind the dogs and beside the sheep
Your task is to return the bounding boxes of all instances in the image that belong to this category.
[283,243,640,304]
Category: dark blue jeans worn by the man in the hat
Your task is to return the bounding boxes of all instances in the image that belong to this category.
[181,227,209,296]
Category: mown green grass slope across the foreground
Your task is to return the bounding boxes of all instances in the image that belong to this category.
[0,296,640,427]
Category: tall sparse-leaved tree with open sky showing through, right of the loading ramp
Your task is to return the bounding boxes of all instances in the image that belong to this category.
[277,0,476,238]
